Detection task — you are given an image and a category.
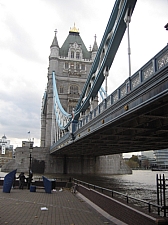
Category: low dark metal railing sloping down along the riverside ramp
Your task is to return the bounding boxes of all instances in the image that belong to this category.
[73,179,163,215]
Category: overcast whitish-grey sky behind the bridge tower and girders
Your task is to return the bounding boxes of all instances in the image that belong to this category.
[0,0,168,157]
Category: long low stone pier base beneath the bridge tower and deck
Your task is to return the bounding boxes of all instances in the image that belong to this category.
[1,147,131,175]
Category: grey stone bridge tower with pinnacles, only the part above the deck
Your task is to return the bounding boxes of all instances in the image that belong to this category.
[41,24,98,147]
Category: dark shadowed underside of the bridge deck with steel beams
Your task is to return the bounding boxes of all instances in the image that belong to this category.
[51,90,168,156]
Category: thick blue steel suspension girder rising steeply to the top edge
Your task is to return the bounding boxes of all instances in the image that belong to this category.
[74,0,136,120]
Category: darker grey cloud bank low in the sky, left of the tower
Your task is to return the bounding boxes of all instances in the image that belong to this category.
[0,86,41,138]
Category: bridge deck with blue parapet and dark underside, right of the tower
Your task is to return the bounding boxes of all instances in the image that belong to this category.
[50,45,168,156]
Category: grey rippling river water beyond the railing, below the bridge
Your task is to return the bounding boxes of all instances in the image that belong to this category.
[0,170,168,206]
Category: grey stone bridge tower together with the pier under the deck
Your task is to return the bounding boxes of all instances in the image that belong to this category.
[41,25,130,174]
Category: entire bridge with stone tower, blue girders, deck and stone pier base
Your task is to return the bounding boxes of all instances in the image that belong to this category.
[2,0,168,175]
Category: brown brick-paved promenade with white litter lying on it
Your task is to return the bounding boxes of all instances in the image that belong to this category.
[0,187,124,225]
